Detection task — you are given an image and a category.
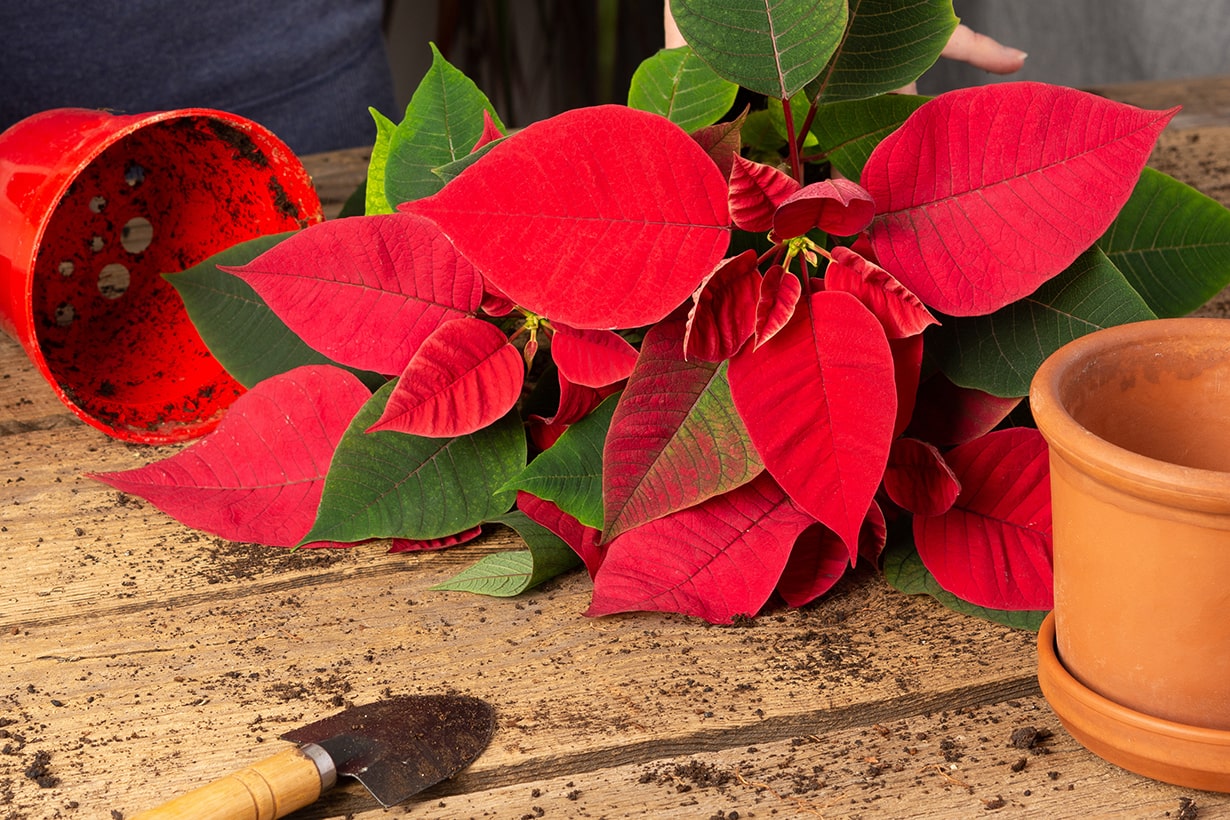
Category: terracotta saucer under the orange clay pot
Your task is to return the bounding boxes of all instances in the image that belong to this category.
[1038,612,1230,792]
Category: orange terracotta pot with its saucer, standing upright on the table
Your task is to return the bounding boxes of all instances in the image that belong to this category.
[1030,318,1230,790]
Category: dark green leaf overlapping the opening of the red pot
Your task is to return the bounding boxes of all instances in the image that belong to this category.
[164,231,384,387]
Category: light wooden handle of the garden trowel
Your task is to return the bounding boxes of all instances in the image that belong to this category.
[133,747,321,820]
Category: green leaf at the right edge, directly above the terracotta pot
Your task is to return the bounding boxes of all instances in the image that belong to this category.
[1097,168,1230,317]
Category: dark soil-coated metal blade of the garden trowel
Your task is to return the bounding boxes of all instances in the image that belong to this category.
[282,695,496,808]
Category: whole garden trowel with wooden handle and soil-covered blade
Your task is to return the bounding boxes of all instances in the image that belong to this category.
[134,695,496,820]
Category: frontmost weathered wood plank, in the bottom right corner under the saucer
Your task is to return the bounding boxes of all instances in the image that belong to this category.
[396,696,1230,820]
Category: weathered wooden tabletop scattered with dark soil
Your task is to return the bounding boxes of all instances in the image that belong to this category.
[0,78,1230,820]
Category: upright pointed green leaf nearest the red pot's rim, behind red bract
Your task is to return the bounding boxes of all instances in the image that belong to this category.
[384,44,504,207]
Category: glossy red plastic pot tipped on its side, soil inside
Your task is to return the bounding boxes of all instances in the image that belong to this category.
[0,108,322,444]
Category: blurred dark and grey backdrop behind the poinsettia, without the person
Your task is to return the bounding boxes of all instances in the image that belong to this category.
[386,0,1230,120]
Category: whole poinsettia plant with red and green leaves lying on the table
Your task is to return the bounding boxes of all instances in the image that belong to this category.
[91,0,1230,623]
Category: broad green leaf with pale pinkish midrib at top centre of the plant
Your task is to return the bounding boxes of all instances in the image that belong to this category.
[670,0,846,100]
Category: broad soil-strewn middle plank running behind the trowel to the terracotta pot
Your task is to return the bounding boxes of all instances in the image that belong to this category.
[0,540,1036,811]
